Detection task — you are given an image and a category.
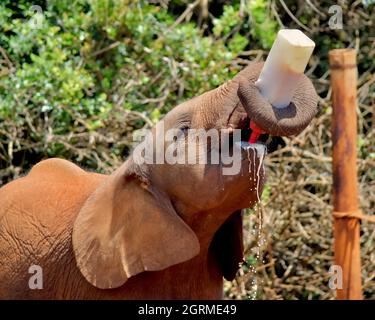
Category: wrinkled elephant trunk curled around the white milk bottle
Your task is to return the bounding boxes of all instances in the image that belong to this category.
[237,63,318,136]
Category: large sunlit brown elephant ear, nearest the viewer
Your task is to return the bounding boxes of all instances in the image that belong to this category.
[73,162,199,289]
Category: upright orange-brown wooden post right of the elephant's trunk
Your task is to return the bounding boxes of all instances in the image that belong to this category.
[329,49,362,299]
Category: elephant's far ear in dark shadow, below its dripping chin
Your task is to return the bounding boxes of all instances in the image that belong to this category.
[211,210,244,281]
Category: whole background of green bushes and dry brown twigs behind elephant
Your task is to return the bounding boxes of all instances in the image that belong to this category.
[0,0,375,299]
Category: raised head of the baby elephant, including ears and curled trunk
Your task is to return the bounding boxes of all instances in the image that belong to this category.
[73,64,317,288]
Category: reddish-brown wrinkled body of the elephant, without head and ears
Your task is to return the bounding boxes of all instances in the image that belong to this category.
[0,159,228,299]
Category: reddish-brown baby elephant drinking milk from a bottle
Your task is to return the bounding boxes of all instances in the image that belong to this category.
[0,64,317,299]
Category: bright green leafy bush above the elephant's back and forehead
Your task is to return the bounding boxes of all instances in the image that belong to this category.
[0,0,248,175]
